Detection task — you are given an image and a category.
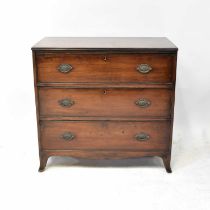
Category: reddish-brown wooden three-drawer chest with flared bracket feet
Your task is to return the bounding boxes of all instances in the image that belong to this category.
[32,37,178,172]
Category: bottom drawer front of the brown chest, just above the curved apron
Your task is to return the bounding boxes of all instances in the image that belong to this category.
[41,121,170,150]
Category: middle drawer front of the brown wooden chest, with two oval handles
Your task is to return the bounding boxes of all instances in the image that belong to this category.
[39,88,172,117]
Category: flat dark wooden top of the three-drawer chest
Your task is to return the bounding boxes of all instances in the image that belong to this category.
[32,37,178,52]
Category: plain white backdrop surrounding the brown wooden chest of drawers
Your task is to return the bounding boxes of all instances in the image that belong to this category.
[0,0,210,210]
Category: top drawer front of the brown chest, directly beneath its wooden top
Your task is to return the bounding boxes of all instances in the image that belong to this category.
[36,53,173,83]
